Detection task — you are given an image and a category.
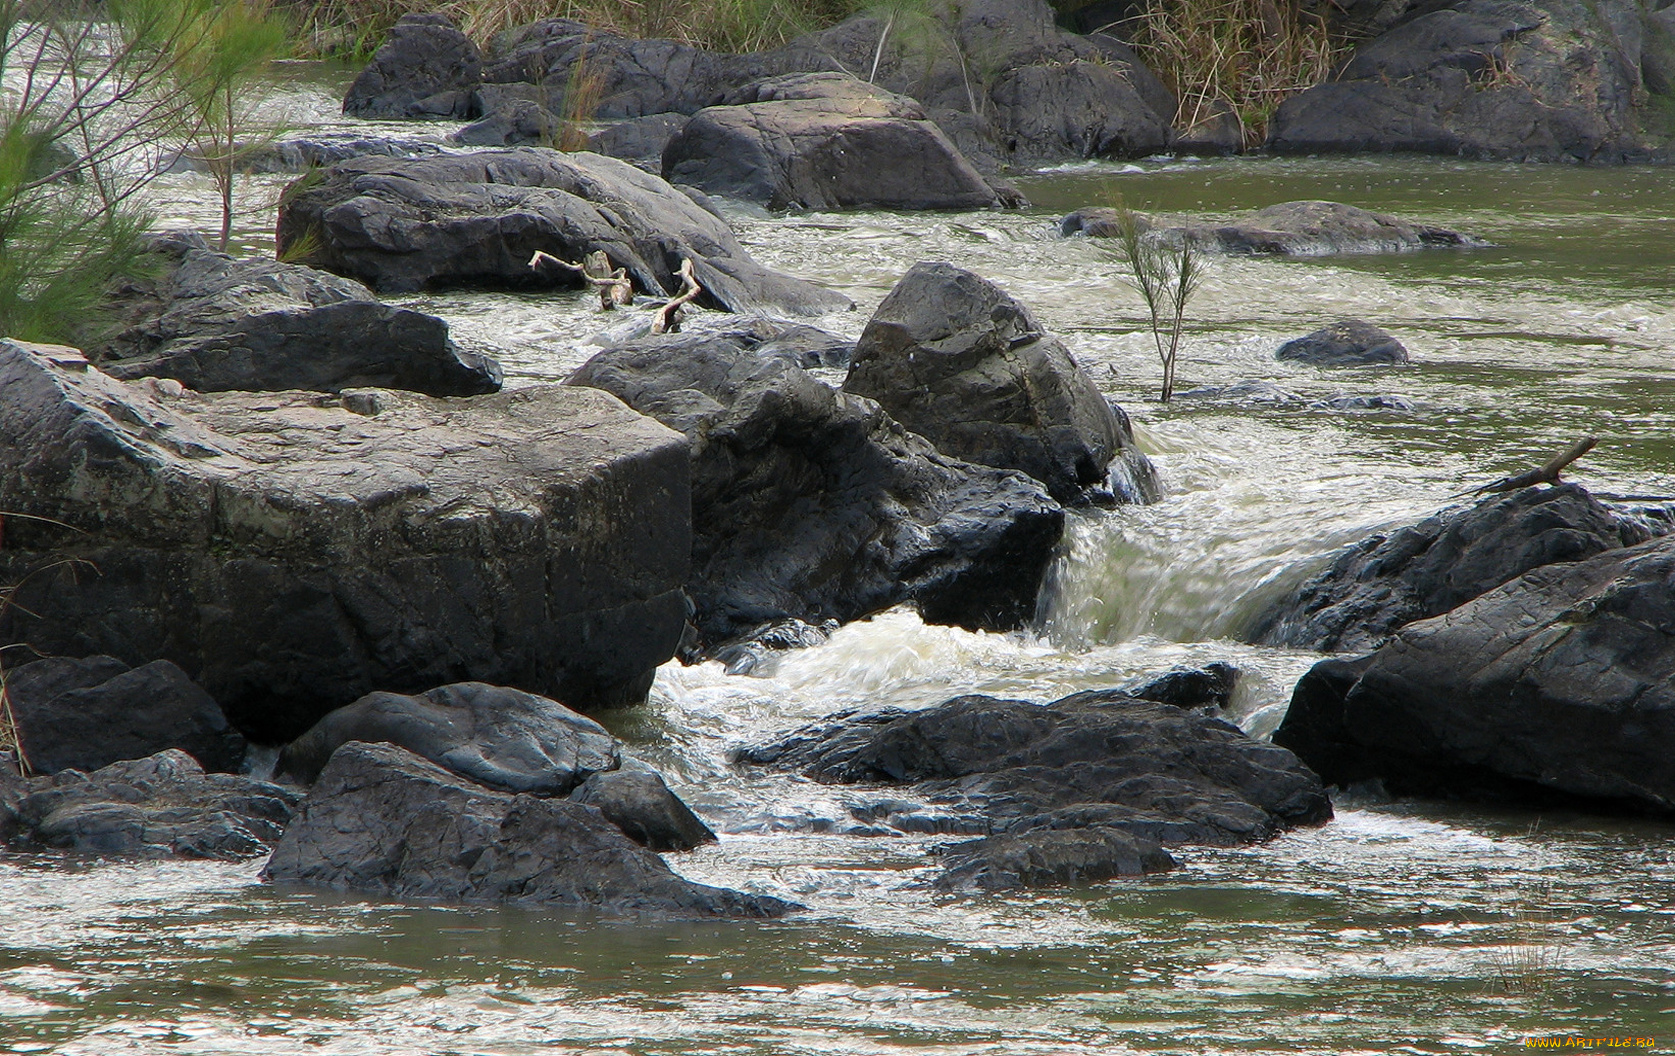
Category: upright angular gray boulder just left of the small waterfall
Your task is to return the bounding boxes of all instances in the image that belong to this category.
[844,261,1161,503]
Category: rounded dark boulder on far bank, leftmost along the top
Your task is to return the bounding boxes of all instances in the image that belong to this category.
[343,13,482,119]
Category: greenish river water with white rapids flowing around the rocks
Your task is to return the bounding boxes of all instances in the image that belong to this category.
[0,59,1675,1056]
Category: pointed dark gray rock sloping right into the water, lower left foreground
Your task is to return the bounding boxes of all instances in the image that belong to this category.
[263,741,796,917]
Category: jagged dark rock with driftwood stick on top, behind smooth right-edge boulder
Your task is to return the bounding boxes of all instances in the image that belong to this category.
[1246,484,1647,652]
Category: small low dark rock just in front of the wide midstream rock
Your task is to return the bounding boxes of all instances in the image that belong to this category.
[933,826,1176,892]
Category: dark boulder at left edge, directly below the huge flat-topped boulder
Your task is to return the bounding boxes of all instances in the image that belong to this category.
[5,657,245,774]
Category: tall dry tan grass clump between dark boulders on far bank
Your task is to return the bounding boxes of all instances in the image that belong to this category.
[1124,0,1350,146]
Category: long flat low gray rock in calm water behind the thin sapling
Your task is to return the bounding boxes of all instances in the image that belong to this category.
[1059,201,1487,256]
